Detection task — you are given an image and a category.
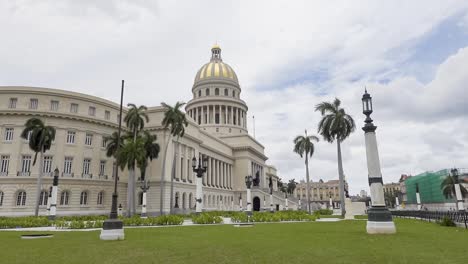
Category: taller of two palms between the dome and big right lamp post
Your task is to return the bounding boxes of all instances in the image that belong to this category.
[315,98,356,216]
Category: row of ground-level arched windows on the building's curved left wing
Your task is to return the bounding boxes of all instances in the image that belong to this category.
[0,190,104,206]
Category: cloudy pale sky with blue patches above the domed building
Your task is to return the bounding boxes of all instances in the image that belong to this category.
[0,0,468,193]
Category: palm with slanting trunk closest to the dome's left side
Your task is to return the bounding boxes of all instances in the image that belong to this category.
[160,102,188,214]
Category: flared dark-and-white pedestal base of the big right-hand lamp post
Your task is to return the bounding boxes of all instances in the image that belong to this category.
[366,206,396,234]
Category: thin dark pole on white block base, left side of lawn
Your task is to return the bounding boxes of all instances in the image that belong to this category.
[99,80,125,240]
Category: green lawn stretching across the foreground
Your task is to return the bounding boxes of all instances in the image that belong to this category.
[0,219,468,264]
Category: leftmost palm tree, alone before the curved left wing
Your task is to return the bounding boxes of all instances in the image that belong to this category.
[21,117,55,216]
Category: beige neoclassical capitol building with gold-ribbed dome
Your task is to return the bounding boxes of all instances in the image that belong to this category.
[0,46,297,215]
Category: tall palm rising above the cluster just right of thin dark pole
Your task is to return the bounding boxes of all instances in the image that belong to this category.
[124,104,149,216]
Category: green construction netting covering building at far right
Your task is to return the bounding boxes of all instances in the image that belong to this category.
[405,169,453,204]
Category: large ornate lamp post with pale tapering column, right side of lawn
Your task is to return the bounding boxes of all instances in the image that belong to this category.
[362,90,396,234]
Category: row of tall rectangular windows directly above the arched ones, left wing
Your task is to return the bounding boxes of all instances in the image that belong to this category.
[0,155,114,177]
